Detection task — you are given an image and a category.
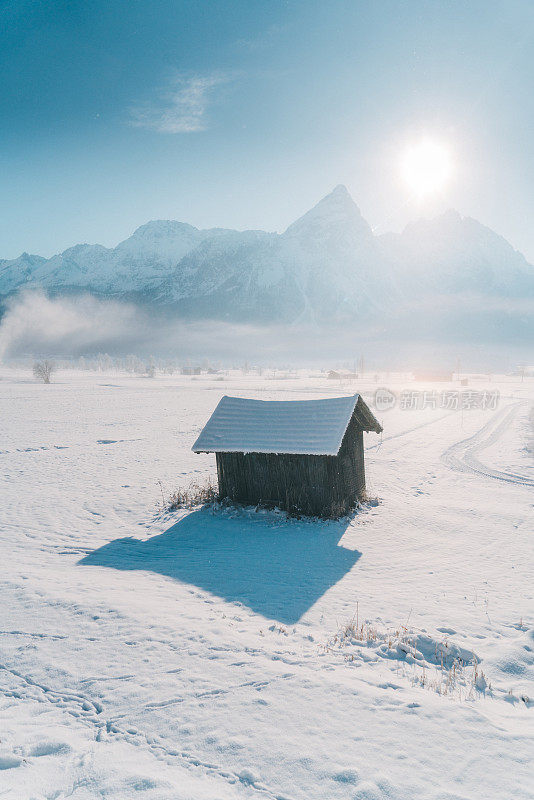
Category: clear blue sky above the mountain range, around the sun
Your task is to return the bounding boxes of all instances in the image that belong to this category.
[0,0,534,262]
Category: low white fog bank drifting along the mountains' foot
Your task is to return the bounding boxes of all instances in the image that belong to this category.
[0,291,534,372]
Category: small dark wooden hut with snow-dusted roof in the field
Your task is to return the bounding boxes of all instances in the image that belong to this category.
[193,394,382,517]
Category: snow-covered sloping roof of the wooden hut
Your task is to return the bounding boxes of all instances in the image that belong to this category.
[193,394,382,456]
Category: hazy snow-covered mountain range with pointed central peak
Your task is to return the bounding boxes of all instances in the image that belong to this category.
[0,186,534,335]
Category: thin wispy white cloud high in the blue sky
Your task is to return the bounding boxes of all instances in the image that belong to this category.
[130,72,232,133]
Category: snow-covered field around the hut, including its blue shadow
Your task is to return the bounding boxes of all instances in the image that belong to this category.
[0,368,534,800]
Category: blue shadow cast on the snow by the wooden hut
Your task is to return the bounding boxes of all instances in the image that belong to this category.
[78,509,361,624]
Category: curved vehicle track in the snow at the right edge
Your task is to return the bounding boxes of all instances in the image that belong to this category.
[441,401,534,487]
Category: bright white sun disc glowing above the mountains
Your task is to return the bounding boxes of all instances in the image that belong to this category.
[400,139,453,200]
